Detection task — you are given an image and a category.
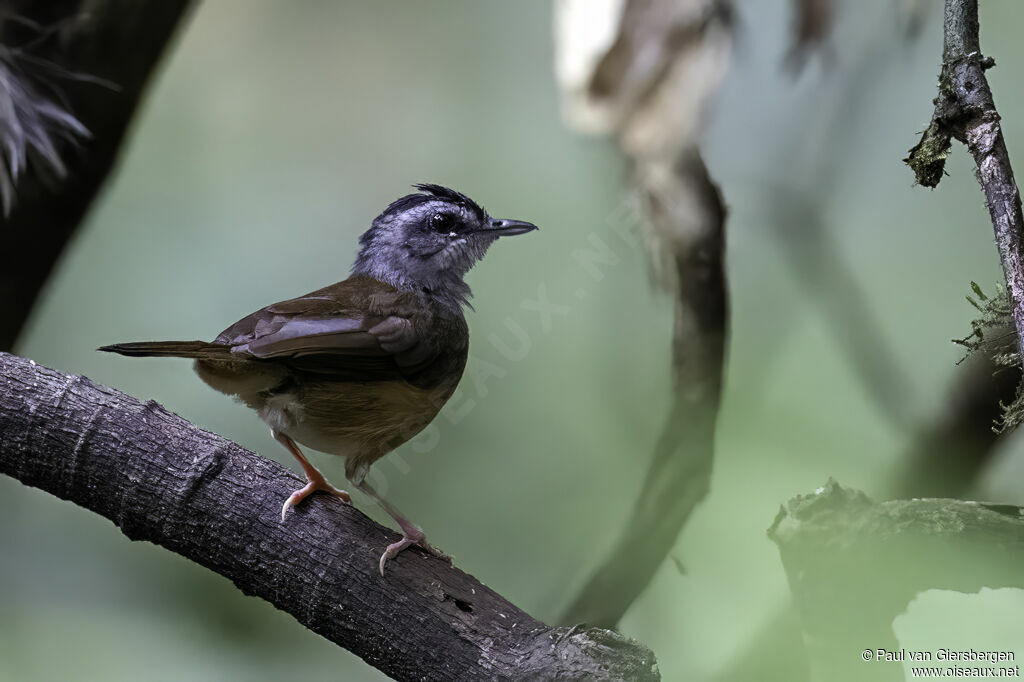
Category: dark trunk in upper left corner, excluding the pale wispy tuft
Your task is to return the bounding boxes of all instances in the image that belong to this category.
[0,0,190,350]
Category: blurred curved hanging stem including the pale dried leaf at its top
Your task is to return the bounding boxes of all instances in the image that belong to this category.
[558,0,732,628]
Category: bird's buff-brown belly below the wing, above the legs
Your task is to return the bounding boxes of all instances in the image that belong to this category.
[259,381,451,459]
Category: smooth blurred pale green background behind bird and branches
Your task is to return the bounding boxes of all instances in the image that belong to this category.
[6,0,1024,681]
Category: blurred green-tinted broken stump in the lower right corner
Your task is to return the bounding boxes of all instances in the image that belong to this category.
[768,480,1024,682]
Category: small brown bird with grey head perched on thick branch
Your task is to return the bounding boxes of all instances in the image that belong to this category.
[98,183,538,577]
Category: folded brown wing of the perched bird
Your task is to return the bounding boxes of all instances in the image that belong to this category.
[216,276,436,381]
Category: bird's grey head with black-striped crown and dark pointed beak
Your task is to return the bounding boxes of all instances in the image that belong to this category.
[352,184,537,309]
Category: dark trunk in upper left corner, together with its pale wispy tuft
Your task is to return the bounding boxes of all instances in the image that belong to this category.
[0,0,190,350]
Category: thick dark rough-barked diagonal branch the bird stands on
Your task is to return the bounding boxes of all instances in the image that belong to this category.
[0,353,659,680]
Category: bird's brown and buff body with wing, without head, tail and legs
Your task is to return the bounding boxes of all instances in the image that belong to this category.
[196,276,469,456]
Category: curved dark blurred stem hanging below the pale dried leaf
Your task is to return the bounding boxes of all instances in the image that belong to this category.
[560,150,727,628]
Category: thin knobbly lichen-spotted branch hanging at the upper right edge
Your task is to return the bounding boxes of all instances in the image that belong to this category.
[904,0,1024,357]
